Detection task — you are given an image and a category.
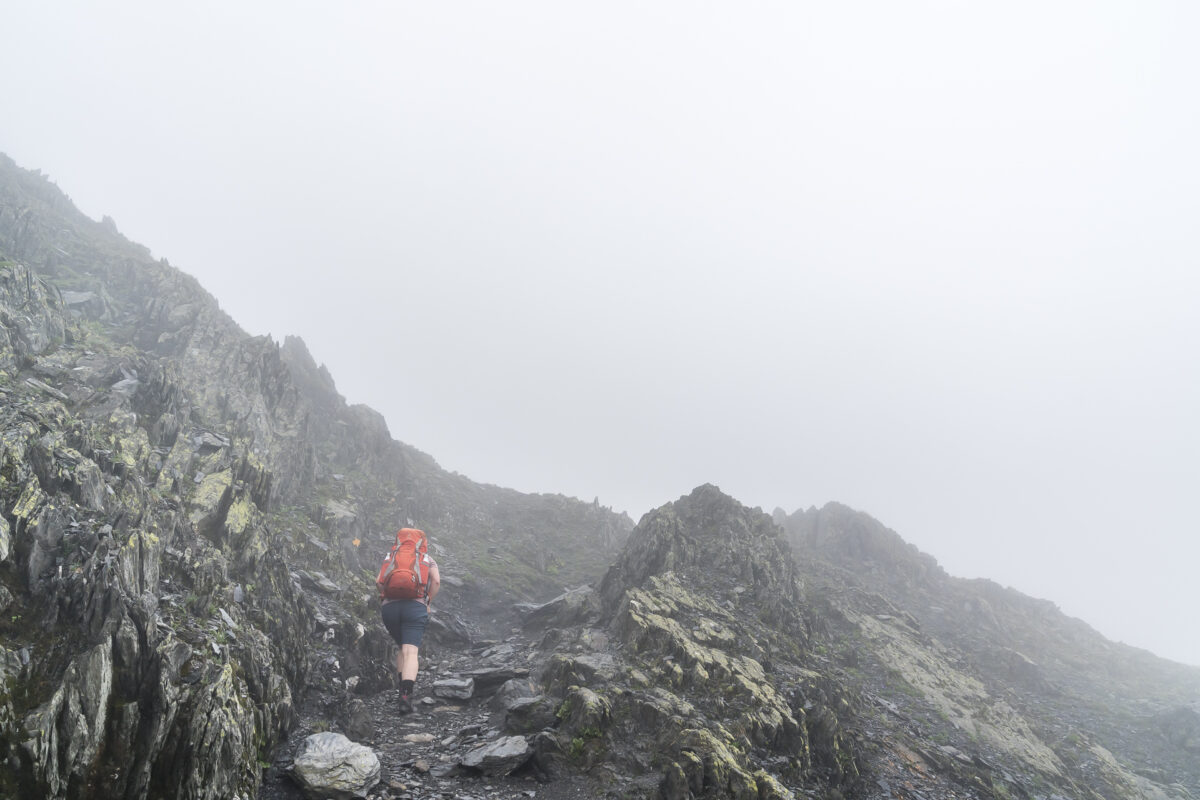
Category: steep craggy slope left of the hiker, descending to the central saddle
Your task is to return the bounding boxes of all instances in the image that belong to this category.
[0,157,631,798]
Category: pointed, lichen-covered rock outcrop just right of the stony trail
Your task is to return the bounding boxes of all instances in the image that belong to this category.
[513,486,859,798]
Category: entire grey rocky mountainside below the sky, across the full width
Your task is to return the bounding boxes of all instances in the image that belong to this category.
[0,151,1200,800]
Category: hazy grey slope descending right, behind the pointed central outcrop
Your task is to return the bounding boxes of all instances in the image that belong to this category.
[774,504,1200,798]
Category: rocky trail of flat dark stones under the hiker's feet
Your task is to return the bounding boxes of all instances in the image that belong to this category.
[259,628,628,800]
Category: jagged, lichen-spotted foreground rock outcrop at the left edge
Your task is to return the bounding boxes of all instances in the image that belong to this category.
[0,257,308,798]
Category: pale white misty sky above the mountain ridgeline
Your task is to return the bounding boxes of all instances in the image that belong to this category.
[0,1,1200,664]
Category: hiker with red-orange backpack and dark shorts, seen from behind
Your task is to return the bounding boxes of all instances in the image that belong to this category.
[376,528,442,714]
